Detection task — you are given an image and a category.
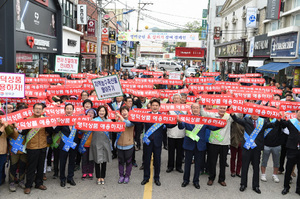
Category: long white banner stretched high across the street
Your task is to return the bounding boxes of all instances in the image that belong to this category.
[118,32,199,42]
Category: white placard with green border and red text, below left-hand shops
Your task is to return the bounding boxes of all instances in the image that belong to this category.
[55,55,79,74]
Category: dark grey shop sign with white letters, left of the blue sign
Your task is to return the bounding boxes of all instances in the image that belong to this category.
[253,34,271,57]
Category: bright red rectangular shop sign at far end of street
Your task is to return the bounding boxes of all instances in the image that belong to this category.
[175,47,205,58]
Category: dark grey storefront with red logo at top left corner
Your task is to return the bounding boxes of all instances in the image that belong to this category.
[0,0,62,77]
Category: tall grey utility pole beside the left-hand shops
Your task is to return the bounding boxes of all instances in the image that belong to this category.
[96,0,102,72]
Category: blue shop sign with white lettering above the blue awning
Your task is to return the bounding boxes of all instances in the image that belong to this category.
[271,32,298,58]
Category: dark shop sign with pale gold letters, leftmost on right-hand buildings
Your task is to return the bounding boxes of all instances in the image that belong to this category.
[215,41,245,57]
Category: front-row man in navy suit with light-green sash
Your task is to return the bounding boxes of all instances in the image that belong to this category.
[178,103,220,189]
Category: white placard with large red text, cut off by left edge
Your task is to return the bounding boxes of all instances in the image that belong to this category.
[0,73,25,98]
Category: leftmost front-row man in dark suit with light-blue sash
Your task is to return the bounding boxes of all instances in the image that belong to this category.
[55,104,79,187]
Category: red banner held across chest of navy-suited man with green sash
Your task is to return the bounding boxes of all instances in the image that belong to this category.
[179,115,227,127]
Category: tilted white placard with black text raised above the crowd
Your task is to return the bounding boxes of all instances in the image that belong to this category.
[92,75,123,100]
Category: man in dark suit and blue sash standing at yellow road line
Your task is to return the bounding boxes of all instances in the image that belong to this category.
[141,98,166,186]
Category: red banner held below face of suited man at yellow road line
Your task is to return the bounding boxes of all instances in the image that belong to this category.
[128,111,177,124]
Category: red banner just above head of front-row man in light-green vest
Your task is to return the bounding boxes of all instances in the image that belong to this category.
[200,95,244,106]
